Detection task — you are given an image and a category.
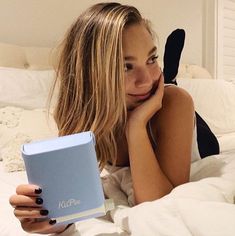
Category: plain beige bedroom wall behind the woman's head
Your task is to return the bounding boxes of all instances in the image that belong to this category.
[0,0,203,65]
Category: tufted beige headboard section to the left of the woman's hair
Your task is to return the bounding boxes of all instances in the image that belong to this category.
[0,43,56,70]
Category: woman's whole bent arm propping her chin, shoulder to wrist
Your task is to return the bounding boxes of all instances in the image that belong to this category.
[126,86,194,203]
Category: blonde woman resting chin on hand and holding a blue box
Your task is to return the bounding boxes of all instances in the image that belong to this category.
[10,3,194,234]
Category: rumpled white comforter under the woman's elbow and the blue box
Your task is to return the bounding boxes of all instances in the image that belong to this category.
[0,136,235,236]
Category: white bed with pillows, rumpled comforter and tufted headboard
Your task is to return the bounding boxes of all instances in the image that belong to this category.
[0,44,235,236]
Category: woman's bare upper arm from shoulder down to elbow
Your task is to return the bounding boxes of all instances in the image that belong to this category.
[155,86,195,187]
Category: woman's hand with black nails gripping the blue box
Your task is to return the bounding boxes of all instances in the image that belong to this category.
[9,184,67,234]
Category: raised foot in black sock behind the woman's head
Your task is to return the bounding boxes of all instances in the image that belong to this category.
[163,29,185,85]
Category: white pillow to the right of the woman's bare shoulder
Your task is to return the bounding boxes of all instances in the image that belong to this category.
[177,79,235,135]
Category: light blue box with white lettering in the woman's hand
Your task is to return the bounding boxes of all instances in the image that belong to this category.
[22,131,106,224]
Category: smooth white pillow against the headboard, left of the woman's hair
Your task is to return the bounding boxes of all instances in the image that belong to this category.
[0,67,55,109]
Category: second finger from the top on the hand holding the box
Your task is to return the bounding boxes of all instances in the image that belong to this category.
[9,195,43,207]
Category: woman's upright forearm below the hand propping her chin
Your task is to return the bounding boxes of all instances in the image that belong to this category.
[127,124,173,204]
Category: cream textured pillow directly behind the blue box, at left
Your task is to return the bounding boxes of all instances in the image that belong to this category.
[0,107,58,171]
